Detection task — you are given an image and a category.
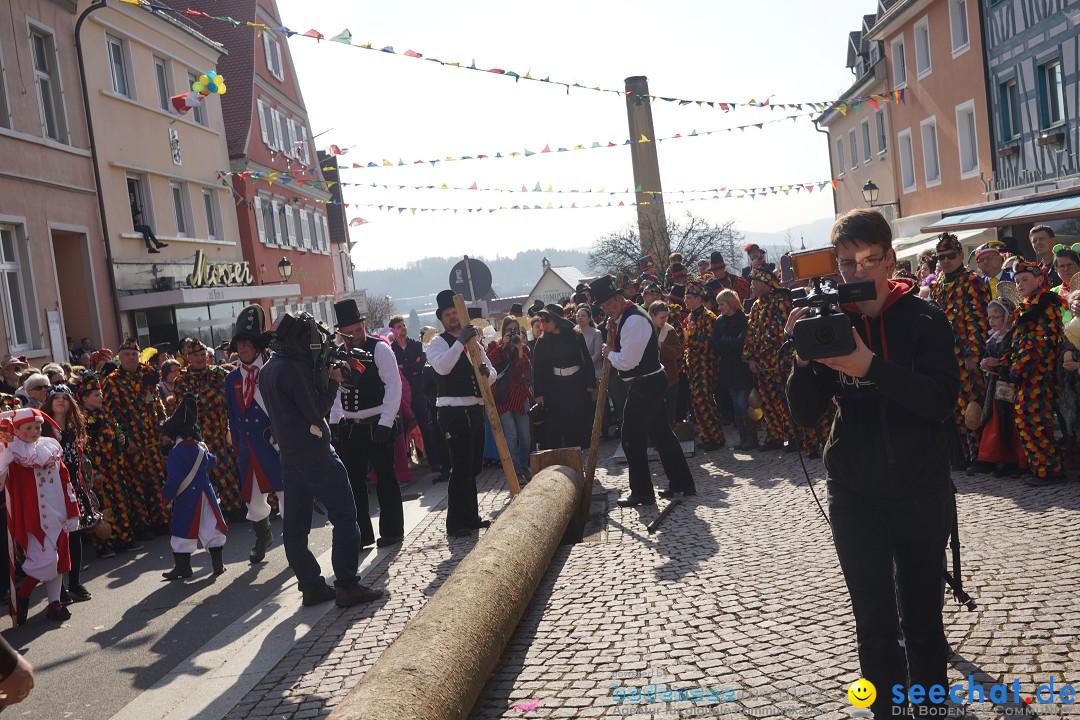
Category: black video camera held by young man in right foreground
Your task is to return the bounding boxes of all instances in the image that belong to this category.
[792,277,877,361]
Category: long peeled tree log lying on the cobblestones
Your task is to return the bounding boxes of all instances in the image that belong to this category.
[329,466,584,720]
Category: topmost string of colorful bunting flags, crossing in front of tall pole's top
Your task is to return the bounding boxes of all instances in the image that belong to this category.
[120,0,904,114]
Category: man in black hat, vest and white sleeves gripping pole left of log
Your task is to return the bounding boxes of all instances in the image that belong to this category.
[428,290,496,538]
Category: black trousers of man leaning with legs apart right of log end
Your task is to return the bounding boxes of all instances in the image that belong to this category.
[612,372,694,498]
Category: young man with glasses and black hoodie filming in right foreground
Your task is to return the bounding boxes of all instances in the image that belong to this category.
[785,209,960,718]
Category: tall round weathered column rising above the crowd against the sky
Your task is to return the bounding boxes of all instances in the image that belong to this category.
[626,76,671,257]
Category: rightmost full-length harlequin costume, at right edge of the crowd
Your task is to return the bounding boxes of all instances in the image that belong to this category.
[1003,261,1065,478]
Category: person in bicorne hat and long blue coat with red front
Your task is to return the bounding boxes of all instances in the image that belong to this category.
[225,304,285,563]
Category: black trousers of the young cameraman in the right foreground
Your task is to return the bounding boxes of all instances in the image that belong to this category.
[828,479,950,718]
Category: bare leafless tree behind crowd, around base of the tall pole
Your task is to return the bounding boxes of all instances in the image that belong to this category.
[589,212,744,277]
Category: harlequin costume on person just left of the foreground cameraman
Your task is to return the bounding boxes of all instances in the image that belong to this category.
[743,268,794,447]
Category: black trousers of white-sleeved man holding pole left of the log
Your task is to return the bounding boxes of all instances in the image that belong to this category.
[438,405,484,532]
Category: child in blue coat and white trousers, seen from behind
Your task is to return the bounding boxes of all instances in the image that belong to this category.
[161,395,229,580]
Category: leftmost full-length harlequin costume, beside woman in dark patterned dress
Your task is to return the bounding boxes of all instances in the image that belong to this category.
[78,372,136,547]
